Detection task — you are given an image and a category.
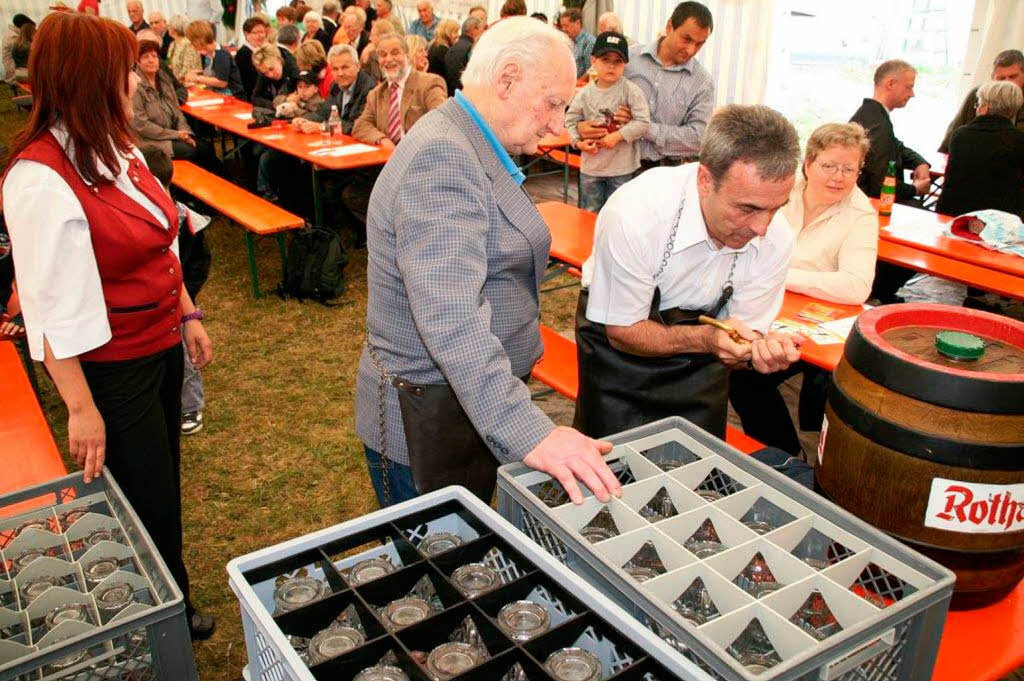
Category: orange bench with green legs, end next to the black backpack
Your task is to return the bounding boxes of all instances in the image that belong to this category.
[171,161,305,298]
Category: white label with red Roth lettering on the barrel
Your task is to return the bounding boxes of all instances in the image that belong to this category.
[925,477,1024,535]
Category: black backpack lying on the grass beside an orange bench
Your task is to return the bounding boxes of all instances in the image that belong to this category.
[278,223,348,304]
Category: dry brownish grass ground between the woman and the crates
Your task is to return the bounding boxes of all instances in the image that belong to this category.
[0,88,575,681]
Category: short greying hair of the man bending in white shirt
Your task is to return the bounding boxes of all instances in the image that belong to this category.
[700,104,800,186]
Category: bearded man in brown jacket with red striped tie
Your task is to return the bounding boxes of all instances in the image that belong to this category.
[352,34,447,150]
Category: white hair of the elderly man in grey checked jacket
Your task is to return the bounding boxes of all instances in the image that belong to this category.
[462,16,575,87]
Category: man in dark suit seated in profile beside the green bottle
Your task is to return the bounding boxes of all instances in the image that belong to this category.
[850,59,932,304]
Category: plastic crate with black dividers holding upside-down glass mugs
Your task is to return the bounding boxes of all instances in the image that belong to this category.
[227,486,710,681]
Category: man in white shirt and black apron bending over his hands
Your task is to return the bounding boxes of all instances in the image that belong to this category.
[573,104,800,437]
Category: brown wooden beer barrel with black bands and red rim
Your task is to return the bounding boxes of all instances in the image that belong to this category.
[817,304,1024,607]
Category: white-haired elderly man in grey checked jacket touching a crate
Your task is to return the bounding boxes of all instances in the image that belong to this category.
[356,17,621,506]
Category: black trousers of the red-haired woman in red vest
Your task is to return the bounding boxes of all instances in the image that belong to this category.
[82,343,193,619]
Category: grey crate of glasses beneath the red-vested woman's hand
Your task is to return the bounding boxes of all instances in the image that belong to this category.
[0,469,199,681]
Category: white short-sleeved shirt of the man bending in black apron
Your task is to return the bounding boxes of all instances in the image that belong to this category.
[583,163,794,332]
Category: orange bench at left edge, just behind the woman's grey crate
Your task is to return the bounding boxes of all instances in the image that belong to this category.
[0,341,68,514]
